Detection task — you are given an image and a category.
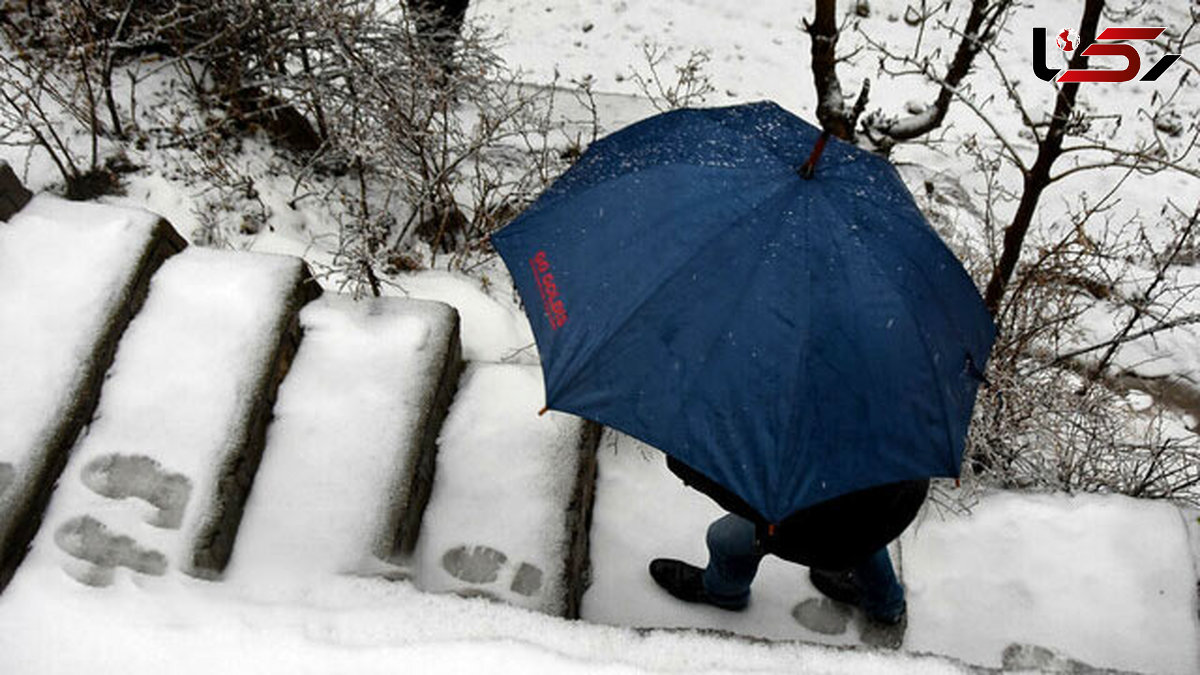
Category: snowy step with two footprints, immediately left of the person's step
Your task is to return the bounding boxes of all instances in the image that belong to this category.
[412,363,599,617]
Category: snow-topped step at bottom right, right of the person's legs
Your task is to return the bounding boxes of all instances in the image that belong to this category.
[902,494,1200,674]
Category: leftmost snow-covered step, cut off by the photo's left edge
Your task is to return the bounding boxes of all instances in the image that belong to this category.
[0,195,186,590]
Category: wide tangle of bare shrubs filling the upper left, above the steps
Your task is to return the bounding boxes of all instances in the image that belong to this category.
[6,0,590,278]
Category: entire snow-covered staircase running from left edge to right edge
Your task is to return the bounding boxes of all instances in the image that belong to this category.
[0,183,1200,673]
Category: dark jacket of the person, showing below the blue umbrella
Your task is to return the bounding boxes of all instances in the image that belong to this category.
[667,456,929,571]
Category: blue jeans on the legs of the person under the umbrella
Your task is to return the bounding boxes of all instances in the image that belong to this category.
[704,513,905,617]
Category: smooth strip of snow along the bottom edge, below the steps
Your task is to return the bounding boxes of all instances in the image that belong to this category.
[0,569,966,675]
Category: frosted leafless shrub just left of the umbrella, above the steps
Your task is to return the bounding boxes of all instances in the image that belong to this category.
[279,5,576,285]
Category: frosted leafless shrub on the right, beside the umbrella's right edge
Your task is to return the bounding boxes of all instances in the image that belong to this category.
[966,181,1200,503]
